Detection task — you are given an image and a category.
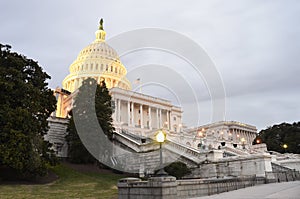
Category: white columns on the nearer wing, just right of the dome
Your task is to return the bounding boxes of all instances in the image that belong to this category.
[115,99,170,130]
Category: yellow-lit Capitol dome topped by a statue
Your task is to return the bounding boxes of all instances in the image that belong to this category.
[63,20,131,92]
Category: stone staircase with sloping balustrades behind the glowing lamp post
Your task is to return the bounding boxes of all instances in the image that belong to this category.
[114,131,206,172]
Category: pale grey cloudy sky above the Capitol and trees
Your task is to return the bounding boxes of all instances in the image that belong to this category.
[0,0,300,129]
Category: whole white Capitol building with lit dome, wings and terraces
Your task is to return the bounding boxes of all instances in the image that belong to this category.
[46,21,300,178]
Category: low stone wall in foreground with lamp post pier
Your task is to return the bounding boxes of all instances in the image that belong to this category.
[118,176,265,199]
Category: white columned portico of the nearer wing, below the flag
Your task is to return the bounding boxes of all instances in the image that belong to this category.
[110,88,182,134]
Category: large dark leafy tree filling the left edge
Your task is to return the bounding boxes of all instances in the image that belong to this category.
[0,44,56,176]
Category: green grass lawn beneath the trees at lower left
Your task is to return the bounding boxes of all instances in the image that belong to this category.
[0,164,124,199]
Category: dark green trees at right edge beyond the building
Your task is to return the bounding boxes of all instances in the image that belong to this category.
[253,122,300,154]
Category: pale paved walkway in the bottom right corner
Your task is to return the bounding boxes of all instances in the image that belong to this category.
[193,181,300,199]
